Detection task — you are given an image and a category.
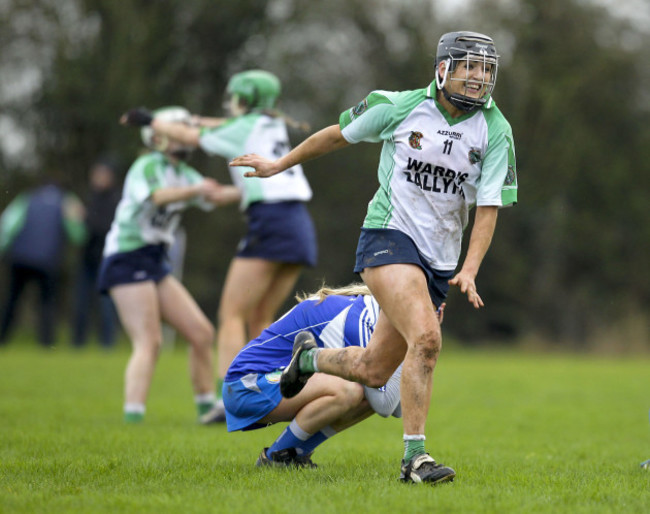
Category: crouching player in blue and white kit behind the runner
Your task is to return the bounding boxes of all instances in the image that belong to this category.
[223,284,428,467]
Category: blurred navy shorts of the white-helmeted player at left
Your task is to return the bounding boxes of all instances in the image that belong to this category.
[97,244,171,294]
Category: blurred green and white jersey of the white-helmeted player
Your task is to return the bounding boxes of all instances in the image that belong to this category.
[104,152,214,256]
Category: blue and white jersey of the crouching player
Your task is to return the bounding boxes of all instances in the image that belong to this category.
[225,295,379,382]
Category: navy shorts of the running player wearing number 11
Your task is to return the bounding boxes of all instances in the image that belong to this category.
[354,228,454,307]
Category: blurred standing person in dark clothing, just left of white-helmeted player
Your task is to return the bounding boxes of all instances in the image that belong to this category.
[72,160,121,348]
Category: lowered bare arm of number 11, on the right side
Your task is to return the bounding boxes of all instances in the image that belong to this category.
[449,206,498,309]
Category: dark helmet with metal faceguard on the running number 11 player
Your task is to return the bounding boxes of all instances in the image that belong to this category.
[435,31,499,112]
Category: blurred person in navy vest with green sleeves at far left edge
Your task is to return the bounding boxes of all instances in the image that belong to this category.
[0,179,85,346]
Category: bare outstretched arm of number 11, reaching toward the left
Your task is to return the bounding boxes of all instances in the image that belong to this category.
[230,125,349,177]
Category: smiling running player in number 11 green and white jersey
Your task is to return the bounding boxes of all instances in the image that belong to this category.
[230,31,517,484]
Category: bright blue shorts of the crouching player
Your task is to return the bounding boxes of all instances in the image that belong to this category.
[223,370,282,432]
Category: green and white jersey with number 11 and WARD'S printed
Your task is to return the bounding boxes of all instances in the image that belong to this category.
[339,83,517,271]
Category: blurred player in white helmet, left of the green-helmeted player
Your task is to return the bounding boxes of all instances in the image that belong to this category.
[109,107,230,422]
